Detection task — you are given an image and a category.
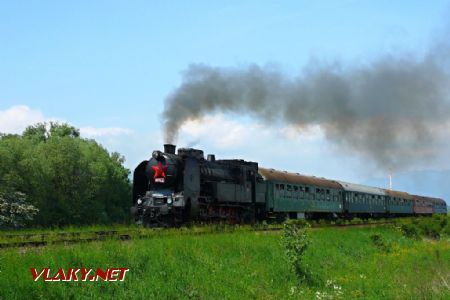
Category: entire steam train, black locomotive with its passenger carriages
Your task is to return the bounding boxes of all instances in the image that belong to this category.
[131,144,447,226]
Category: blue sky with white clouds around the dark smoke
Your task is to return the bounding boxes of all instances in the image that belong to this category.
[0,0,450,193]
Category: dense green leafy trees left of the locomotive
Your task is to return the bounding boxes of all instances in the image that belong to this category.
[0,122,131,227]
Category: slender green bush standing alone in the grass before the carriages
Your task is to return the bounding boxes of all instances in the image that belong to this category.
[281,220,310,281]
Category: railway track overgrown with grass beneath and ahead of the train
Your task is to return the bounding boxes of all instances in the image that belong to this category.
[0,222,394,249]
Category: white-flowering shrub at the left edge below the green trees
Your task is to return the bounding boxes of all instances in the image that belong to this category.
[0,192,39,228]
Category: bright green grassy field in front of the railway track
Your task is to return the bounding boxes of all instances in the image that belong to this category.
[0,227,450,299]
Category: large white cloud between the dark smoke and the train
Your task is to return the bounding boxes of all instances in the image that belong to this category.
[174,114,355,178]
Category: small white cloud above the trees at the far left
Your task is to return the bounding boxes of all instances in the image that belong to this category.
[0,105,46,134]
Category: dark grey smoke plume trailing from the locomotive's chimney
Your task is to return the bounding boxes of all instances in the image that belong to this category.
[163,47,450,170]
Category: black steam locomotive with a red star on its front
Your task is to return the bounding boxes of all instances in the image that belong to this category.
[132,144,265,226]
